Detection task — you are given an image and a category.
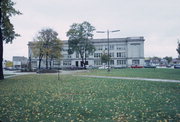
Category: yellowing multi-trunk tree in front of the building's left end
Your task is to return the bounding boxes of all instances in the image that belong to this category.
[32,28,63,69]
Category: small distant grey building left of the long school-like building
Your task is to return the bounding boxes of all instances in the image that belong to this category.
[13,56,28,69]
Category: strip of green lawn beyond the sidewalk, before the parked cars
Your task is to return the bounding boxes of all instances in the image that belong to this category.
[80,68,180,80]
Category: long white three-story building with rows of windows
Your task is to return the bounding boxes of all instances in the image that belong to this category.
[28,37,145,68]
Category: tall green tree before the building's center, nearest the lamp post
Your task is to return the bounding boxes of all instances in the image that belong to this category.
[67,21,95,68]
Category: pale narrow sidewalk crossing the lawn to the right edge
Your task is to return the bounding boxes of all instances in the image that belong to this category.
[74,75,180,83]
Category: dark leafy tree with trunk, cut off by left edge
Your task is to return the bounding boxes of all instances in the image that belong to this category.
[0,0,21,80]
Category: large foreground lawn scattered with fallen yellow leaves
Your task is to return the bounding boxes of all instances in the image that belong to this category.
[0,75,180,122]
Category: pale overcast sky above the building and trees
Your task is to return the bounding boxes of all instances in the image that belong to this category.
[4,0,180,60]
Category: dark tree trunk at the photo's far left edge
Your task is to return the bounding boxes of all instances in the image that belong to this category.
[0,8,4,80]
